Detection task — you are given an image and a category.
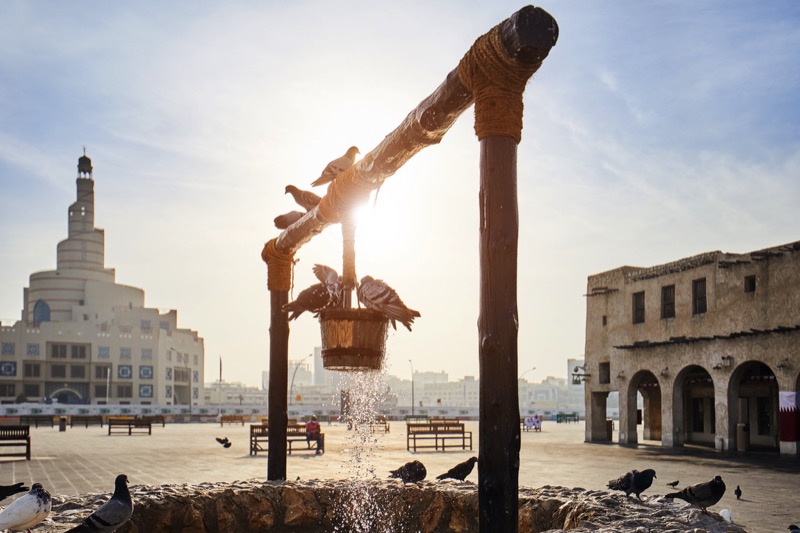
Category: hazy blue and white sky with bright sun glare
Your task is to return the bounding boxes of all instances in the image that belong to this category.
[0,0,800,385]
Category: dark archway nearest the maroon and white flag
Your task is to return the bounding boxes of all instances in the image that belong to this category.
[728,361,780,451]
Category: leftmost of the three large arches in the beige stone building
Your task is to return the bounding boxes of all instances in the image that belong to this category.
[620,370,661,444]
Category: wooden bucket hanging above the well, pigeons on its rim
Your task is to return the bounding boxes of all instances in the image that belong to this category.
[319,308,389,371]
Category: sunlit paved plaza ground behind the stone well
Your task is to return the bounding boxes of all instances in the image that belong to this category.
[0,422,800,533]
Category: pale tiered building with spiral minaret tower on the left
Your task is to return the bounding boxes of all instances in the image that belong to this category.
[0,153,204,405]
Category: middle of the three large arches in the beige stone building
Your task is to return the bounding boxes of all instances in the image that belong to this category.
[672,365,717,446]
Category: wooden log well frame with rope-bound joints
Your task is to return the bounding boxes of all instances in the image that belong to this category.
[261,6,558,533]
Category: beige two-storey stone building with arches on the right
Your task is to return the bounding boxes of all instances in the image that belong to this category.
[583,242,800,455]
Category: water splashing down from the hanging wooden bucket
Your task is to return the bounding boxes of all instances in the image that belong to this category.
[335,371,402,533]
